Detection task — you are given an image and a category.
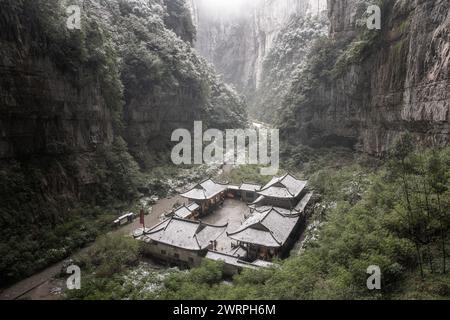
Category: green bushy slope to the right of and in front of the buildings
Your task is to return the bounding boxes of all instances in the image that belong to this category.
[69,142,450,299]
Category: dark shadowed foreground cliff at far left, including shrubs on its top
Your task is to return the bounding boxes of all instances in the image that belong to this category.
[0,1,118,200]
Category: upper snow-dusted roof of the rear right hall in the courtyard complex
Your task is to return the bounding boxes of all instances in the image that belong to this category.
[258,173,307,199]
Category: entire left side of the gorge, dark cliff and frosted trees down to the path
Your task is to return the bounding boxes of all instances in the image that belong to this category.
[0,0,247,285]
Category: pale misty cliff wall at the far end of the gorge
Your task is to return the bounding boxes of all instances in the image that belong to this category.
[191,0,326,117]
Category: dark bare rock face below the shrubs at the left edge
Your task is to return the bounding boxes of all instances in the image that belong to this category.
[0,47,113,158]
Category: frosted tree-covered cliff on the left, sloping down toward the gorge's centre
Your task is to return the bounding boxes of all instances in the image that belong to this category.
[112,0,247,167]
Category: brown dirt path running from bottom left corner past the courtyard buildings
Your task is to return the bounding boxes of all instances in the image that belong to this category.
[0,196,185,300]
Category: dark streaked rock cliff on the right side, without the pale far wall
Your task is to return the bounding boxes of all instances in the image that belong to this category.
[284,0,450,155]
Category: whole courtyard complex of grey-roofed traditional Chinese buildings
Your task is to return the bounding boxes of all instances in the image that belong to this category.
[136,174,312,268]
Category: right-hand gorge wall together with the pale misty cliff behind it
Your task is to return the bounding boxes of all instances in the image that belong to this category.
[192,0,450,156]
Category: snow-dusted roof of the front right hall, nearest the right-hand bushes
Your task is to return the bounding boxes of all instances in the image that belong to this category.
[227,208,299,248]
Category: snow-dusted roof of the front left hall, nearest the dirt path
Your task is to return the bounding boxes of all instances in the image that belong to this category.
[141,217,228,251]
